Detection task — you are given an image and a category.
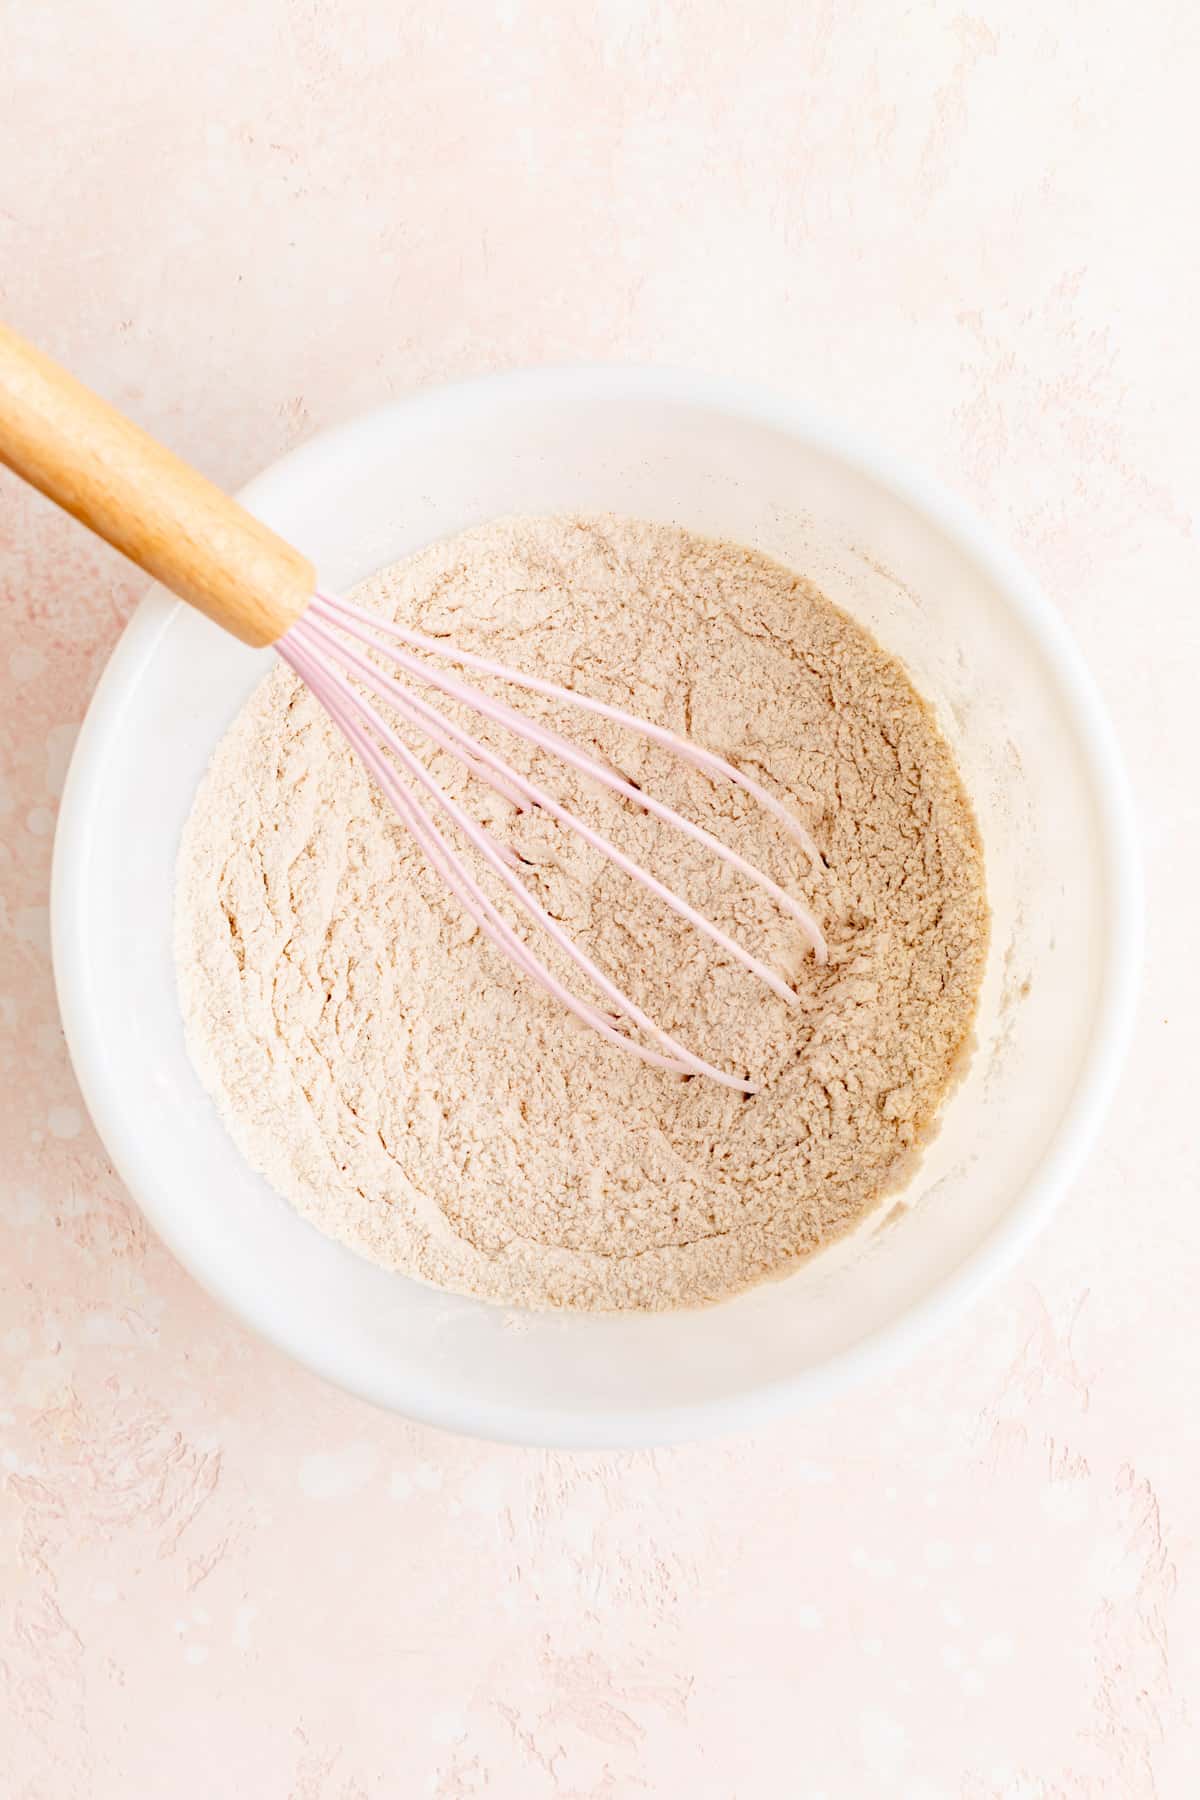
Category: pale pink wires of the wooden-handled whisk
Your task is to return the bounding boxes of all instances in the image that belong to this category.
[275,594,828,1094]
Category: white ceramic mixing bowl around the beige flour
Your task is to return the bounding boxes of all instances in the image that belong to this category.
[52,369,1141,1447]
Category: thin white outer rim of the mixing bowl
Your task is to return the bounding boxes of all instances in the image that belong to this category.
[50,364,1142,1449]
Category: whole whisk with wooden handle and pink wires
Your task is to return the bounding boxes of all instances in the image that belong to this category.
[0,324,828,1093]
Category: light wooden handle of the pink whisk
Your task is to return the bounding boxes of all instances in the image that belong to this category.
[0,322,317,648]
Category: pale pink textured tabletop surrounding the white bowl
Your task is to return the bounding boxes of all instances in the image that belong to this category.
[0,0,1200,1800]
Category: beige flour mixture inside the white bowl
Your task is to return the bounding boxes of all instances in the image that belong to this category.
[176,518,988,1309]
